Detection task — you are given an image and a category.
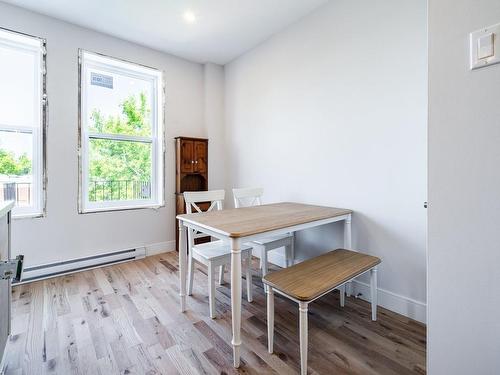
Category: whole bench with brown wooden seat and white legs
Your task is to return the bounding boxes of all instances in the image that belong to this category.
[263,249,381,375]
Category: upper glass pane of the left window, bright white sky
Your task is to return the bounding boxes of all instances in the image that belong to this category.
[0,41,40,127]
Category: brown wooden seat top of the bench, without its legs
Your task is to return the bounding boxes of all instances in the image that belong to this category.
[263,249,381,301]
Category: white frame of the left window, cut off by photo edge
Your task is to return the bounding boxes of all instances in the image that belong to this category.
[0,27,48,218]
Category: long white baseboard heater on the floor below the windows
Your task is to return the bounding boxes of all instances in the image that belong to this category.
[17,247,146,284]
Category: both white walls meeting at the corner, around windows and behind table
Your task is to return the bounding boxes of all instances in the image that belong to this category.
[0,0,426,326]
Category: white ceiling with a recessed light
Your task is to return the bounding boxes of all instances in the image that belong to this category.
[3,0,328,64]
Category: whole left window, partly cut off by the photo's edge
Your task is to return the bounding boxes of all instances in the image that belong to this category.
[0,29,47,217]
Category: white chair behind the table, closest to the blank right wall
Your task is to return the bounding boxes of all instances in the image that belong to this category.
[233,188,295,284]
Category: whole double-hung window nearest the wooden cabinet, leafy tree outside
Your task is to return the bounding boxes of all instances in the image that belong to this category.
[80,50,164,213]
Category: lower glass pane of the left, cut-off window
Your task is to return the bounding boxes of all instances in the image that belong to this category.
[0,131,33,207]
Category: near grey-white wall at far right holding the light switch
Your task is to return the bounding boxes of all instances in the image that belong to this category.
[428,0,500,375]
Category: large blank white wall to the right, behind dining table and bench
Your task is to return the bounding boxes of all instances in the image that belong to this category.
[225,0,427,320]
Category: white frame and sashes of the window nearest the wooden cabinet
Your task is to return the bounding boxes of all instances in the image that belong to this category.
[78,49,165,213]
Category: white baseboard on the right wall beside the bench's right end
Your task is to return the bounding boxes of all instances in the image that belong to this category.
[353,280,427,324]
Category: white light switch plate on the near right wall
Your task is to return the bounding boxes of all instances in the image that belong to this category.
[470,23,500,69]
